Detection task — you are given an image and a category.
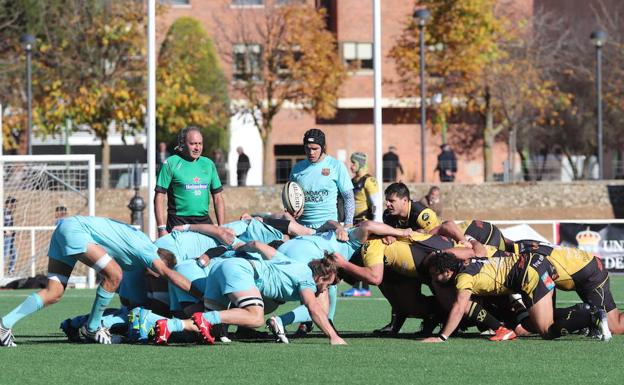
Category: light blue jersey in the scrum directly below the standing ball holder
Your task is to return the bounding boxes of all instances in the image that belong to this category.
[274,227,362,263]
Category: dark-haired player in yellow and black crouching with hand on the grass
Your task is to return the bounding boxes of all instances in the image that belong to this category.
[424,252,608,342]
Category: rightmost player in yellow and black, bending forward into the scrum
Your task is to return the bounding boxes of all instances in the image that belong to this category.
[515,240,624,337]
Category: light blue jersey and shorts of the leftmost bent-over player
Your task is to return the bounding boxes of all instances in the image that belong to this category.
[48,216,158,271]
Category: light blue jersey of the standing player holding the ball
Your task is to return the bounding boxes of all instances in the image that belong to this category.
[290,155,353,229]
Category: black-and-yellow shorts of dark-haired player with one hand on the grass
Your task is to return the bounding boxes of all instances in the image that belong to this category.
[505,253,556,309]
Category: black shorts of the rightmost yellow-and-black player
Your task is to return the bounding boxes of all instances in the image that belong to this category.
[572,257,616,312]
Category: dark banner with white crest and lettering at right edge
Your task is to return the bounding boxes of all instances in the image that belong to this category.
[559,223,624,273]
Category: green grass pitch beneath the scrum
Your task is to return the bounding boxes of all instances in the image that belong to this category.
[0,277,624,385]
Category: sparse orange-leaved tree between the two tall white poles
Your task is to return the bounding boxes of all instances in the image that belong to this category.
[216,4,346,183]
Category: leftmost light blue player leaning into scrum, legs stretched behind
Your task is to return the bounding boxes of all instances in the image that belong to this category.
[0,216,201,346]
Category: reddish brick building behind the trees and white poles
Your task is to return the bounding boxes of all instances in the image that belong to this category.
[157,0,516,184]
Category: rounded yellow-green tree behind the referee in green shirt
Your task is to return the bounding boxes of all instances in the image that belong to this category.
[156,17,230,153]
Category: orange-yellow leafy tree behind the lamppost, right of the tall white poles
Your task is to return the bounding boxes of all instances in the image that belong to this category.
[389,0,502,181]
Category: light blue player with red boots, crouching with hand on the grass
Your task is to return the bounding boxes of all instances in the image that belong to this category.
[155,255,345,345]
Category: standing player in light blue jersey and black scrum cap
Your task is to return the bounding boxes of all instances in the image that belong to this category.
[290,128,355,334]
